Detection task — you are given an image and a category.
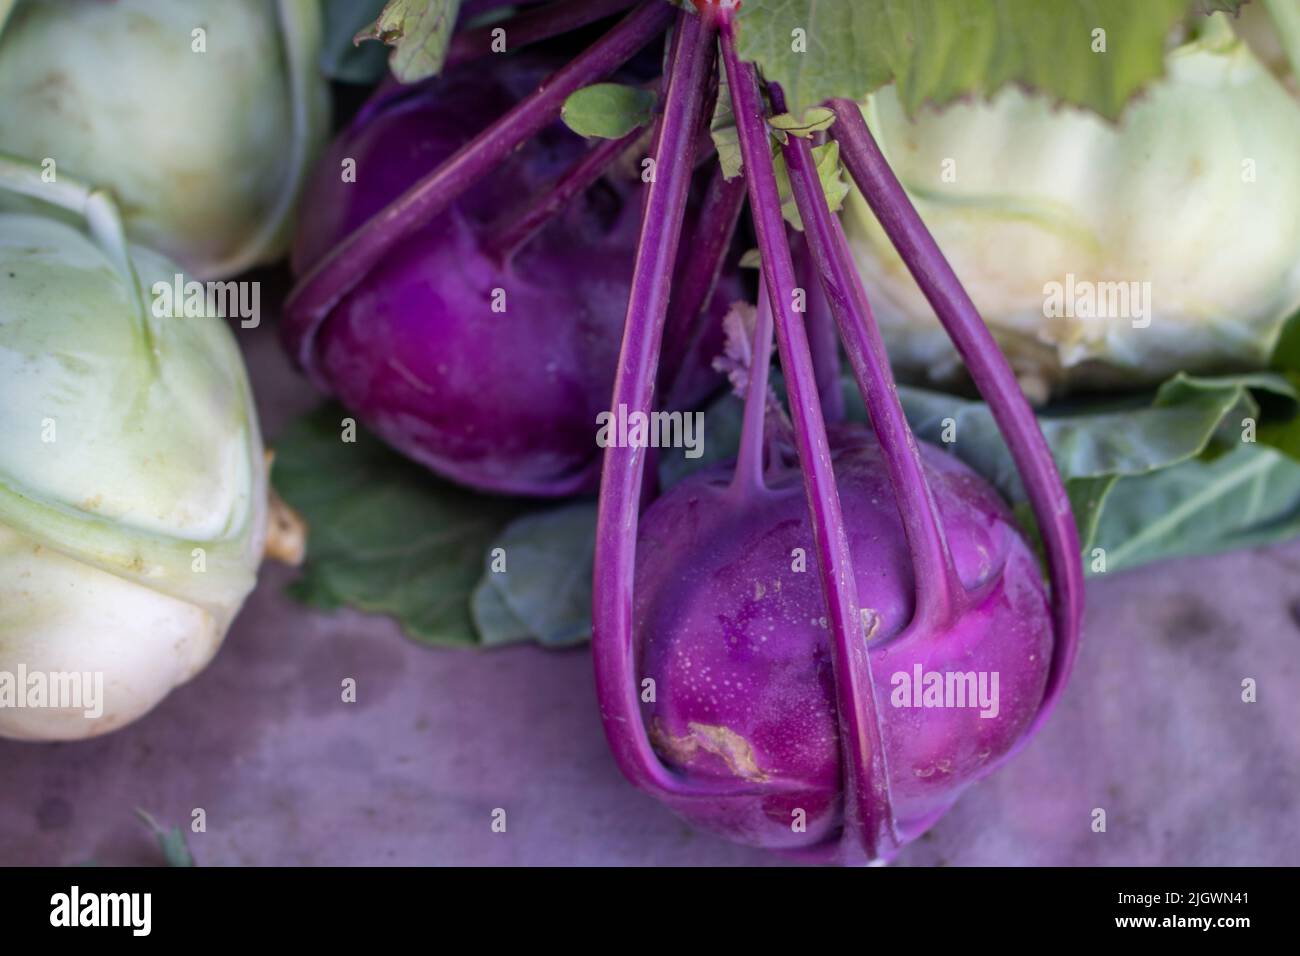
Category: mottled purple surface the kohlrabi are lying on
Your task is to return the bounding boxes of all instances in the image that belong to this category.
[0,325,1300,865]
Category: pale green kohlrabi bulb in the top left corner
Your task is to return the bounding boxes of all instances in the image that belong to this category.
[0,0,329,278]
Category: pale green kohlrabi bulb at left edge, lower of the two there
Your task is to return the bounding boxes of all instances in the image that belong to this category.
[0,160,268,740]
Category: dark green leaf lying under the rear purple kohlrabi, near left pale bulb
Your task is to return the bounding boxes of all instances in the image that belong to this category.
[273,405,523,646]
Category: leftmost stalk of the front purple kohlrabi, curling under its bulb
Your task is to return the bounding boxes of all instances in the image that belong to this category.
[592,10,800,797]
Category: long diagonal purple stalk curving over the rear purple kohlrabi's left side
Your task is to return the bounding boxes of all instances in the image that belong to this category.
[283,0,672,368]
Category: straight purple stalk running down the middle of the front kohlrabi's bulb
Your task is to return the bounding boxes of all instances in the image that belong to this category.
[720,27,897,858]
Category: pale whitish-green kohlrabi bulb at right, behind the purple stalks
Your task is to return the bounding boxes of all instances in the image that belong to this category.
[845,17,1300,401]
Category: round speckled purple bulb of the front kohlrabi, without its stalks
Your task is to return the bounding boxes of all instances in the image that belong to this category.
[636,426,1052,848]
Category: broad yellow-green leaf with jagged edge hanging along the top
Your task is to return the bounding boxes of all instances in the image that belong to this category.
[738,0,1188,118]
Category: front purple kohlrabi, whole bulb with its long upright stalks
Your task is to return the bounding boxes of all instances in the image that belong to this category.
[593,0,1082,862]
